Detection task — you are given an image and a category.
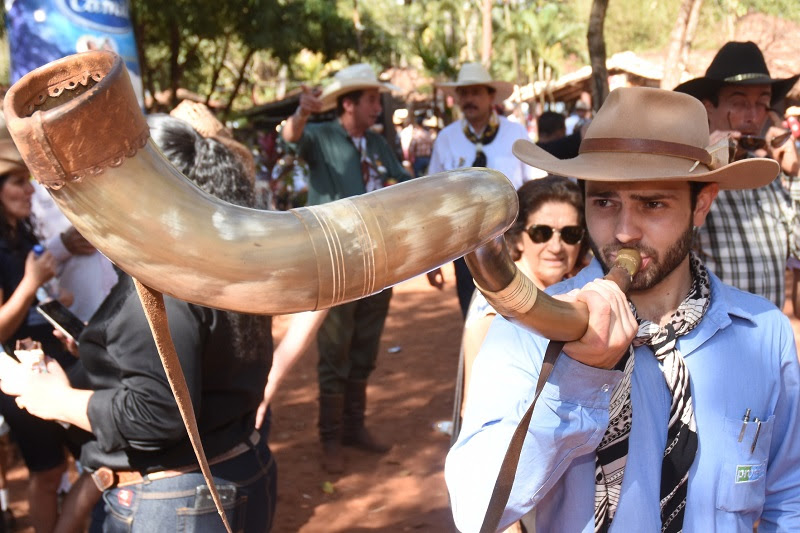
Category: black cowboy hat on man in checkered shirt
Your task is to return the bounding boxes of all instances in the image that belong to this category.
[674,41,800,106]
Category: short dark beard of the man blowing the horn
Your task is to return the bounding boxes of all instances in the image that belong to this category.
[590,226,694,291]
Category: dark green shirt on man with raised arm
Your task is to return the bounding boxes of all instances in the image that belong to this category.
[295,120,411,205]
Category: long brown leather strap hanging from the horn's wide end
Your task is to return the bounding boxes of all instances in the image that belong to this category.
[133,278,232,533]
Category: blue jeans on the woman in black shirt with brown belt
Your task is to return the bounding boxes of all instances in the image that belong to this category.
[97,440,277,533]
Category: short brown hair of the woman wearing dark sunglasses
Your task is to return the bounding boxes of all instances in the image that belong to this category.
[505,174,589,263]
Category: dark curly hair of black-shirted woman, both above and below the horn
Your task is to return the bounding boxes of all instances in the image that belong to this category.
[147,114,272,360]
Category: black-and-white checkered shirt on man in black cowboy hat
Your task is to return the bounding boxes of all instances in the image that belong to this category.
[695,175,800,309]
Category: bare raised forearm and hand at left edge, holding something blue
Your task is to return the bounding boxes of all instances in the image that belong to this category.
[0,251,56,342]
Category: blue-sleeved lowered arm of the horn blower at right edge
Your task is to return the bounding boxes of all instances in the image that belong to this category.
[758,317,800,533]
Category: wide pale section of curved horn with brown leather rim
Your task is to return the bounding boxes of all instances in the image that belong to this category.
[5,51,517,314]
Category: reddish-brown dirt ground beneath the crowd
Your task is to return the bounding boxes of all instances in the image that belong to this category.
[4,267,800,533]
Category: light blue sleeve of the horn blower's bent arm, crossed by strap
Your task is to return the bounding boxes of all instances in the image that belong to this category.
[445,317,623,531]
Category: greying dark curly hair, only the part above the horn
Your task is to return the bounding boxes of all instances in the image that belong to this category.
[147,114,255,207]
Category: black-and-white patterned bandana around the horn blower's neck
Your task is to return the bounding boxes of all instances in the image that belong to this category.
[595,252,711,533]
